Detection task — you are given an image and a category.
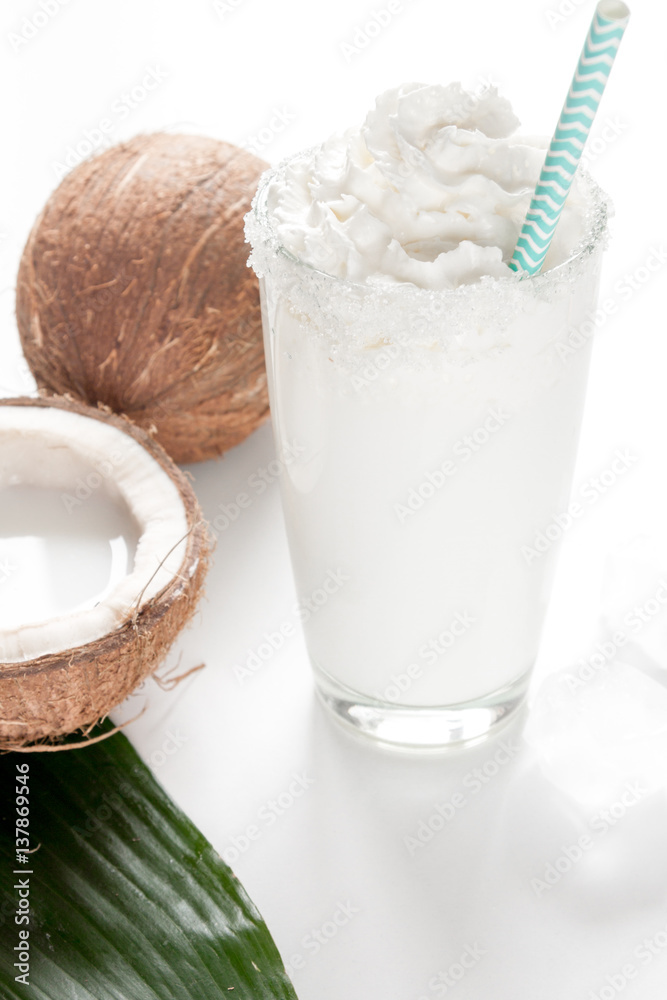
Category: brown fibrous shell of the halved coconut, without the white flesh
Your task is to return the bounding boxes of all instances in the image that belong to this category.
[0,397,210,750]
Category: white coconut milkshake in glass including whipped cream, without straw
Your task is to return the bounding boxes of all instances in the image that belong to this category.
[247,84,607,746]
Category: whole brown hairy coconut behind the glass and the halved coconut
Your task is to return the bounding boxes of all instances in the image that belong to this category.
[16,133,269,462]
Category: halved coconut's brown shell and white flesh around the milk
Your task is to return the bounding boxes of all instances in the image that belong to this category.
[0,397,209,749]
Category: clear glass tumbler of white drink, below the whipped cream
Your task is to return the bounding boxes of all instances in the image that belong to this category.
[247,160,607,749]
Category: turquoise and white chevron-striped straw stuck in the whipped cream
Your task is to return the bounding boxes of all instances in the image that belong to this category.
[509,0,630,275]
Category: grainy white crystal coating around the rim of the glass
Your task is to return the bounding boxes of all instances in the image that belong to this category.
[245,157,613,368]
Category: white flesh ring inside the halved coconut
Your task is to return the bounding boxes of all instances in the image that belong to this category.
[0,405,190,663]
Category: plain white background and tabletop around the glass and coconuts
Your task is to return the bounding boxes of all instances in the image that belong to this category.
[0,0,667,1000]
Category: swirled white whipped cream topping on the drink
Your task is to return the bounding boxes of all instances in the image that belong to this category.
[266,83,586,289]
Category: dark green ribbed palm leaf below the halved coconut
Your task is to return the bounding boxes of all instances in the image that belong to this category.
[0,733,296,1000]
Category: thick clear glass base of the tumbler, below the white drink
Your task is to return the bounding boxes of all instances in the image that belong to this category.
[314,666,530,750]
